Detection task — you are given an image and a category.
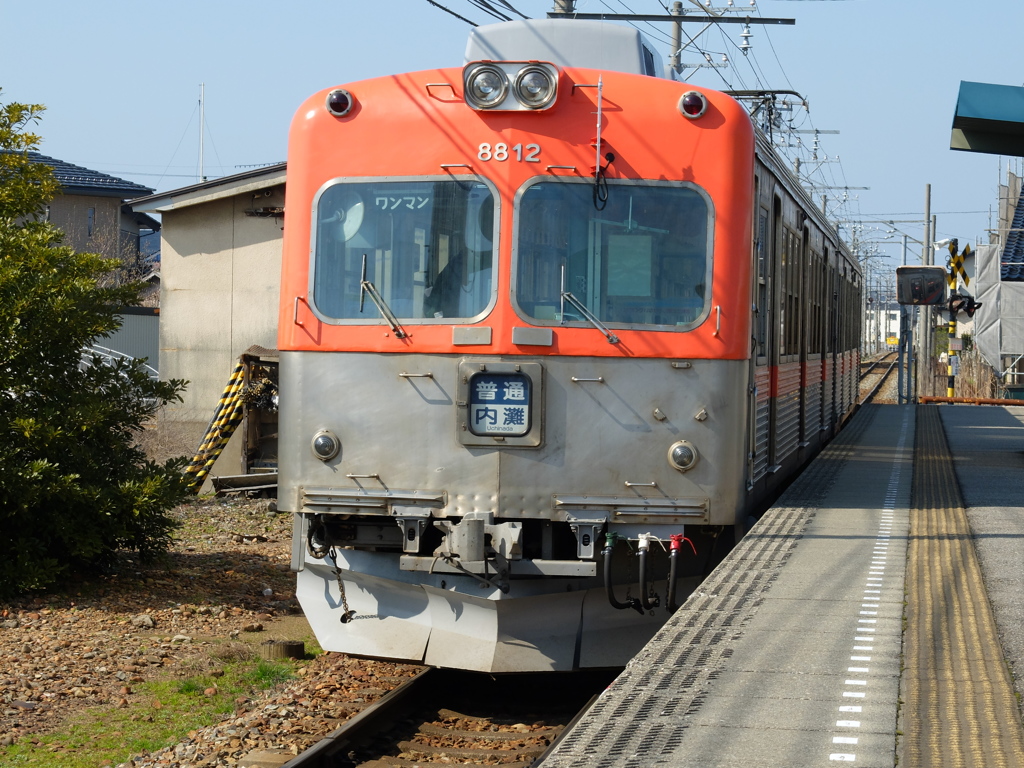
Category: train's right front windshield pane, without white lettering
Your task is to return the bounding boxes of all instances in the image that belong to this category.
[515,181,711,327]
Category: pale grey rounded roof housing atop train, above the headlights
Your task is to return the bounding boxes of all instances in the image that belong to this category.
[466,18,665,77]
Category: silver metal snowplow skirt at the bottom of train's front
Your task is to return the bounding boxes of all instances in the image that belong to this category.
[297,560,679,673]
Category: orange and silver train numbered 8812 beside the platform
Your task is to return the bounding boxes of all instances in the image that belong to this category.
[278,18,861,674]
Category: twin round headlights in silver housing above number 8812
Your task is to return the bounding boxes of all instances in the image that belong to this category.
[462,61,558,111]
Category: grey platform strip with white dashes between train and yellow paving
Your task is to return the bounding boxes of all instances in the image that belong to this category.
[543,406,914,768]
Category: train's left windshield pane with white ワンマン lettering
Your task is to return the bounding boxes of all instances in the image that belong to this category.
[312,180,495,323]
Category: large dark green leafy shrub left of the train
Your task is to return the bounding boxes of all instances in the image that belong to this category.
[0,88,185,595]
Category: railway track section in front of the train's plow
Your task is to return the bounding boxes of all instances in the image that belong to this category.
[285,669,615,768]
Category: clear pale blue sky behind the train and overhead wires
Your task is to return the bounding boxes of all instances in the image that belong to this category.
[0,0,1024,268]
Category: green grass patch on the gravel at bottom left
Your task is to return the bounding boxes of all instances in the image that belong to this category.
[0,653,298,768]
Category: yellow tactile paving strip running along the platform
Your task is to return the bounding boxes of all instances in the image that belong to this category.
[899,406,1024,768]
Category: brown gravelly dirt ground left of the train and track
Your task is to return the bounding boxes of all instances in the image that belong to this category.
[0,499,416,766]
